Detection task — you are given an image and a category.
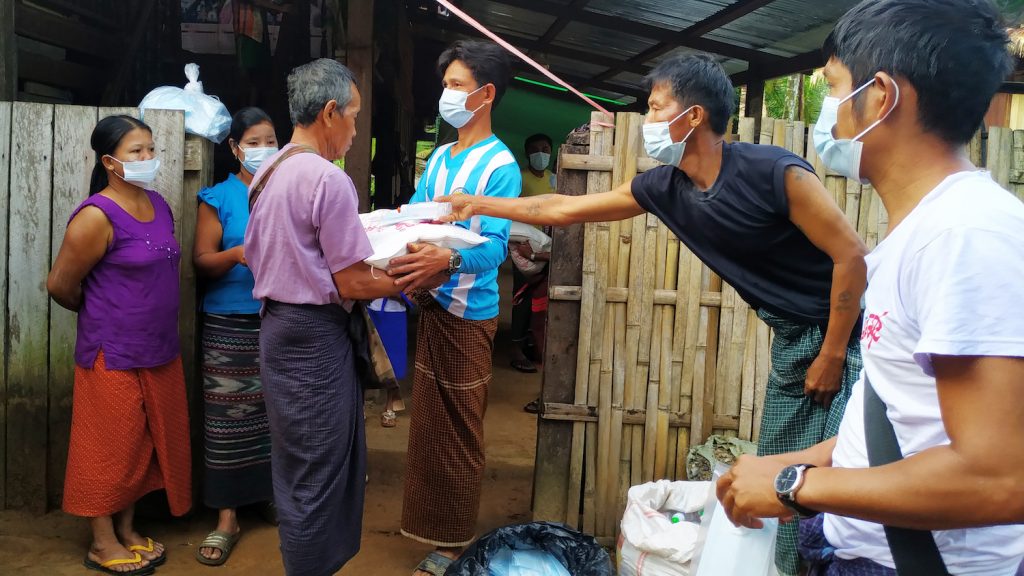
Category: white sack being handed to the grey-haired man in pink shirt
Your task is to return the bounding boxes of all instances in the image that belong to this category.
[359,206,487,269]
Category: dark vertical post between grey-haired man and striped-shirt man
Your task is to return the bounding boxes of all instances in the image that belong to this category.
[345,0,374,212]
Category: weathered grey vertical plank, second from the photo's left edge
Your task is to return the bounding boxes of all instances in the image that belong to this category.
[6,102,53,513]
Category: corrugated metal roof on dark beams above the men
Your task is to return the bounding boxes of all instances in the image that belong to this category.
[411,0,858,97]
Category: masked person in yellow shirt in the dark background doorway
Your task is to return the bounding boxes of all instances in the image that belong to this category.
[509,133,555,377]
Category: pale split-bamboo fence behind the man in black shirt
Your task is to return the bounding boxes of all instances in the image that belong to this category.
[535,113,1024,542]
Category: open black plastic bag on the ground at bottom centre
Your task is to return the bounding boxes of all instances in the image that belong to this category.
[444,522,615,576]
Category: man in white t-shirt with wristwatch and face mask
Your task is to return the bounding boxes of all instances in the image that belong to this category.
[718,0,1024,576]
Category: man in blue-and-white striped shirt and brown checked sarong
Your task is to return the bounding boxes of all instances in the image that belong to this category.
[389,42,522,575]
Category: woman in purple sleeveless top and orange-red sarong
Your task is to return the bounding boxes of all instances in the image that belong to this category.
[46,116,191,576]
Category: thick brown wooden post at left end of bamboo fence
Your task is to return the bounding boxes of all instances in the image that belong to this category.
[534,132,590,522]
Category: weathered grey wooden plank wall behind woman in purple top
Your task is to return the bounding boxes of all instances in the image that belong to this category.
[0,101,212,506]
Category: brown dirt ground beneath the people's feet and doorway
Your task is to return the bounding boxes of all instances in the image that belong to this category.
[0,266,541,576]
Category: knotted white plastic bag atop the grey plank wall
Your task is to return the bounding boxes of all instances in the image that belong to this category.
[138,64,231,143]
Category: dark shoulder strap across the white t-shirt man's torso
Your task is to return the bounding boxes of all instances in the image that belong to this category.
[863,370,949,576]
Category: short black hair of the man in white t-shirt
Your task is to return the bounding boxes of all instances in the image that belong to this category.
[823,0,1012,145]
